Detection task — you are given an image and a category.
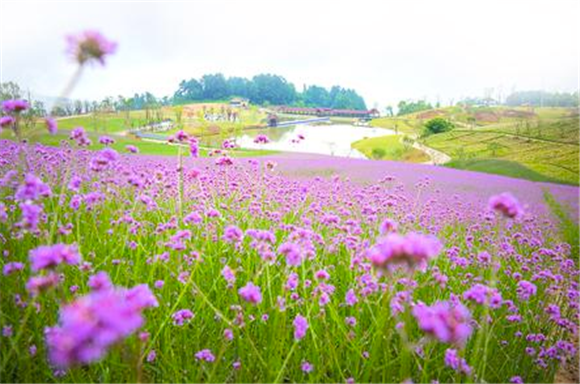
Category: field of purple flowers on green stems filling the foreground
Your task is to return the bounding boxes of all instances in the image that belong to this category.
[0,139,579,383]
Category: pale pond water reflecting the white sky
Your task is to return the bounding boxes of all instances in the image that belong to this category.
[236,124,394,158]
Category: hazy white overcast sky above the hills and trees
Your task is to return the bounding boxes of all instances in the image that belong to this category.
[0,0,580,107]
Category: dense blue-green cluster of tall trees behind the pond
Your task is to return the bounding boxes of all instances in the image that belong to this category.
[173,73,366,110]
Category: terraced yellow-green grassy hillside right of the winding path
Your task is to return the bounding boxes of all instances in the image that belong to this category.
[371,107,580,185]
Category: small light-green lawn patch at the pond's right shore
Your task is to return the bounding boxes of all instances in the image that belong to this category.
[352,135,430,163]
